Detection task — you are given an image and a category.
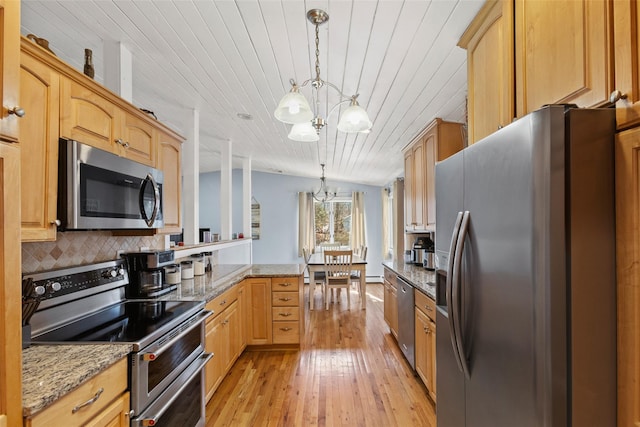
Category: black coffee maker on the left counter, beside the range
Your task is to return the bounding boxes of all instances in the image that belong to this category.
[122,250,177,299]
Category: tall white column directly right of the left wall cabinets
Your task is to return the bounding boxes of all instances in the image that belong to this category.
[182,110,200,245]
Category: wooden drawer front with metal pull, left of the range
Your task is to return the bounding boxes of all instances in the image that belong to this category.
[25,358,127,427]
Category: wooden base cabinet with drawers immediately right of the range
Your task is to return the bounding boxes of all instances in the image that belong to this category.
[205,287,243,401]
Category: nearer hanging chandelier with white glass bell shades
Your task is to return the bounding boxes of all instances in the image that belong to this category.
[274,9,371,142]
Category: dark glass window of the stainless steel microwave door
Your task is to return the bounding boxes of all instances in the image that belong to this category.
[80,163,142,219]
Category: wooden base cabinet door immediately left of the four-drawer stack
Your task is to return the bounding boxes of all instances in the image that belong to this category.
[244,277,273,345]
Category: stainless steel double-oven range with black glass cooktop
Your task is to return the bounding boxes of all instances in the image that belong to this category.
[23,260,211,427]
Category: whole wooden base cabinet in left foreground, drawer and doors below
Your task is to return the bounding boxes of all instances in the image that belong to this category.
[24,358,129,427]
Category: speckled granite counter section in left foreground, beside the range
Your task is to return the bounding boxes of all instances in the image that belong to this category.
[22,344,133,416]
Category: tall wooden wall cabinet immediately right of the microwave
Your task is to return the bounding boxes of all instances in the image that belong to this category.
[157,132,182,234]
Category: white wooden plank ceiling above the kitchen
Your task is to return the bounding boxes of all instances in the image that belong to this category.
[21,0,483,185]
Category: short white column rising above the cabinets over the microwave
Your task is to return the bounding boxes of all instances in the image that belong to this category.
[103,40,133,102]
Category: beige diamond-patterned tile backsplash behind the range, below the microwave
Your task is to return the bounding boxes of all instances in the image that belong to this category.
[22,231,165,273]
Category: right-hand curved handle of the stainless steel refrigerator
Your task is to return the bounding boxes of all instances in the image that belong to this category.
[451,211,471,379]
